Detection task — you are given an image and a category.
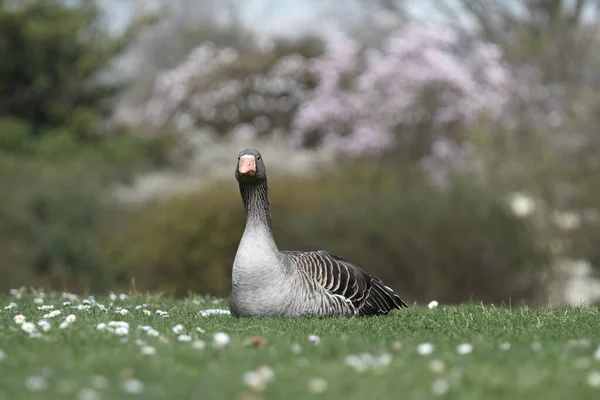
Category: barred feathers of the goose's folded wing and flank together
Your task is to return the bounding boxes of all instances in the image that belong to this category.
[280,250,408,316]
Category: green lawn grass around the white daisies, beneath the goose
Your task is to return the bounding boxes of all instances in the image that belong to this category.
[0,295,600,400]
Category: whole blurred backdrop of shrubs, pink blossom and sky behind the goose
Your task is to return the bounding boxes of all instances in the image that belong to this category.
[0,0,600,306]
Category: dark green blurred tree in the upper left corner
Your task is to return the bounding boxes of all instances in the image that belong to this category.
[0,0,157,136]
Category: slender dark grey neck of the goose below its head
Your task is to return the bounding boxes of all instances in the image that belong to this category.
[240,180,277,248]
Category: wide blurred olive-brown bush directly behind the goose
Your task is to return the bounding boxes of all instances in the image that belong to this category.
[107,162,547,302]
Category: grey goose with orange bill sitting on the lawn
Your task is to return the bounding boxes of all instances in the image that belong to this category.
[229,149,408,318]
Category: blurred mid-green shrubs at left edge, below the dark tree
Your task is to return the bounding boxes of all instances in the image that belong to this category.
[0,126,177,290]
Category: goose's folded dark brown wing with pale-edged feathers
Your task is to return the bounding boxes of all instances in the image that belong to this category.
[281,250,408,315]
